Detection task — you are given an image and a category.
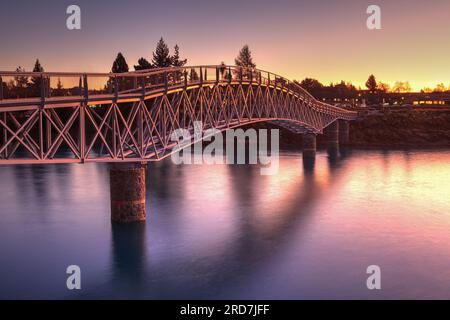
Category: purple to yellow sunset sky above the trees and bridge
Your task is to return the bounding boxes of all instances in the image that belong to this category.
[0,0,450,90]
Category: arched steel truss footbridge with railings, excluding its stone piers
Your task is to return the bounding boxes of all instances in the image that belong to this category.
[0,66,356,164]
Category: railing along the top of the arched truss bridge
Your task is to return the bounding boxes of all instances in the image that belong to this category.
[0,65,351,119]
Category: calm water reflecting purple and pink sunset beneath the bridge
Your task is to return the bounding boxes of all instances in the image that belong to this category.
[0,151,450,299]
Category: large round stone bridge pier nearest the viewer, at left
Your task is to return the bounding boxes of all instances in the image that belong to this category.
[109,162,147,223]
